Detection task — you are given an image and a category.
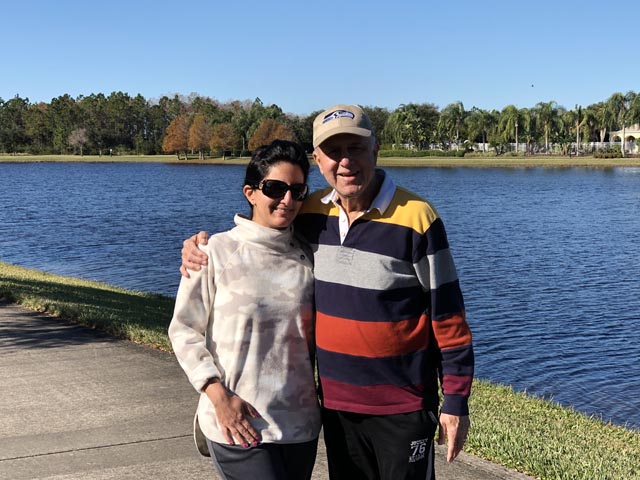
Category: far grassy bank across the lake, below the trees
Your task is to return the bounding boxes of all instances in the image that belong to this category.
[0,155,640,168]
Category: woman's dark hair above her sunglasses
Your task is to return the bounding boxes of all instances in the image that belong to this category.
[244,140,309,187]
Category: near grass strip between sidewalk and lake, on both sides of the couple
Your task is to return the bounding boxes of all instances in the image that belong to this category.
[0,262,640,480]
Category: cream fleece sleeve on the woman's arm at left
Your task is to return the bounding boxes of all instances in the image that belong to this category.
[168,248,222,392]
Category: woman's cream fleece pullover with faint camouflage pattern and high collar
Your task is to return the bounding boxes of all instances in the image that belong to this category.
[169,215,320,443]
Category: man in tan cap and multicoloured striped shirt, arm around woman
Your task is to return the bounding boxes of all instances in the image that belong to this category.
[181,105,474,480]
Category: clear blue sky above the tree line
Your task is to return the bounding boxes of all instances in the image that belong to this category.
[5,0,640,115]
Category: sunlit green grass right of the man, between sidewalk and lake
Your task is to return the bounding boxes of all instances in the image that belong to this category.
[465,380,640,480]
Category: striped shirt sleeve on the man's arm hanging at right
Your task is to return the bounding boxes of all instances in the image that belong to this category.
[418,218,474,415]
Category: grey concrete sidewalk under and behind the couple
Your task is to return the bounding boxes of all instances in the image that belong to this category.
[0,303,529,480]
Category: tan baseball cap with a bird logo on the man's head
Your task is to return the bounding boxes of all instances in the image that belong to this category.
[313,104,373,148]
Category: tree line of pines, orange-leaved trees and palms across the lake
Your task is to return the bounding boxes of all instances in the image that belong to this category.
[0,91,640,158]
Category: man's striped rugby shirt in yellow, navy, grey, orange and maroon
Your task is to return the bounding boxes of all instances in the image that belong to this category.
[296,170,474,415]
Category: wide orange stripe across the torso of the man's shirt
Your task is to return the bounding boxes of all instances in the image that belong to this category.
[316,312,429,358]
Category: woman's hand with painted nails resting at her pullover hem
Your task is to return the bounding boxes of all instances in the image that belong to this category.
[204,381,260,448]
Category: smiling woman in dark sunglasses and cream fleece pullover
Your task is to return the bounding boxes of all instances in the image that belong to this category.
[169,140,320,480]
